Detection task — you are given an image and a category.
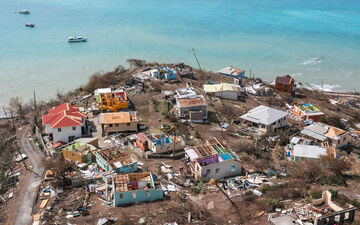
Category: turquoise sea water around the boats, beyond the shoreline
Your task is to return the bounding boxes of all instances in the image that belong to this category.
[0,0,360,105]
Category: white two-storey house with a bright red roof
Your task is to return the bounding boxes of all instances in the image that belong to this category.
[42,103,86,144]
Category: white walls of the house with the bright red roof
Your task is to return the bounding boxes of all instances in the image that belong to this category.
[45,124,81,143]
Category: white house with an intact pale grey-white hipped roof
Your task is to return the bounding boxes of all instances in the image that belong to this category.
[240,105,288,133]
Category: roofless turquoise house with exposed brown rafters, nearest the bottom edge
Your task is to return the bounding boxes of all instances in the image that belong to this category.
[111,172,164,206]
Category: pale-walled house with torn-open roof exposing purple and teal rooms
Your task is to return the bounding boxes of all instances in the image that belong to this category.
[185,138,241,180]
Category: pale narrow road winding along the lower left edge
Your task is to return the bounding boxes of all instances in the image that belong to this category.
[14,126,44,225]
